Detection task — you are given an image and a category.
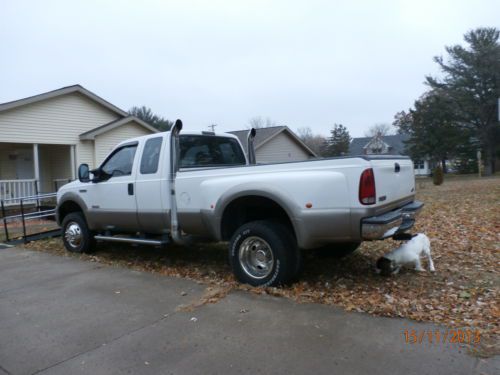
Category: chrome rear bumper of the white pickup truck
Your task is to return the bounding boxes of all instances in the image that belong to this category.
[361,201,424,240]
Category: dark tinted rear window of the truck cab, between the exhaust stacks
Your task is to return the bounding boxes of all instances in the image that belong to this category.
[179,135,245,168]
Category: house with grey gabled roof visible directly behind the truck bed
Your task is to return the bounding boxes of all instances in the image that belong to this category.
[228,126,318,164]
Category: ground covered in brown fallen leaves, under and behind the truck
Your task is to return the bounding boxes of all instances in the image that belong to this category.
[26,178,500,355]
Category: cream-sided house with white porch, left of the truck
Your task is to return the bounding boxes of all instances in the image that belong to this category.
[0,85,157,203]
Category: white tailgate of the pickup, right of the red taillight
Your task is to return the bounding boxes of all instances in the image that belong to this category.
[370,158,415,204]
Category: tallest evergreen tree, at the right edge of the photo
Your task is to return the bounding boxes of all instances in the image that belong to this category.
[427,28,500,174]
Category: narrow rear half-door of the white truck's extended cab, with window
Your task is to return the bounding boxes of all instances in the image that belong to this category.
[135,135,170,234]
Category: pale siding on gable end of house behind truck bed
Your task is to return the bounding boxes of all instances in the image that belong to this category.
[255,133,310,163]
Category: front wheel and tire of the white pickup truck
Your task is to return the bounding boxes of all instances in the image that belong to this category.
[62,212,95,253]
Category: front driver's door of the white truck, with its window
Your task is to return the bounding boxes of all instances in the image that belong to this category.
[87,142,138,231]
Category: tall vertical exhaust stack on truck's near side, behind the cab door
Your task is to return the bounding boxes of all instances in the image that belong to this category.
[168,120,189,245]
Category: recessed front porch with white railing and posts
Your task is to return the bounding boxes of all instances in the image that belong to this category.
[0,143,76,206]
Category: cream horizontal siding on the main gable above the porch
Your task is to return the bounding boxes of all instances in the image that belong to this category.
[0,93,120,144]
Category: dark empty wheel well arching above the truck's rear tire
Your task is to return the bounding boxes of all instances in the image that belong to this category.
[221,195,295,240]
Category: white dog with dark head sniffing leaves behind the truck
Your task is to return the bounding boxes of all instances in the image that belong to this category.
[376,233,435,276]
